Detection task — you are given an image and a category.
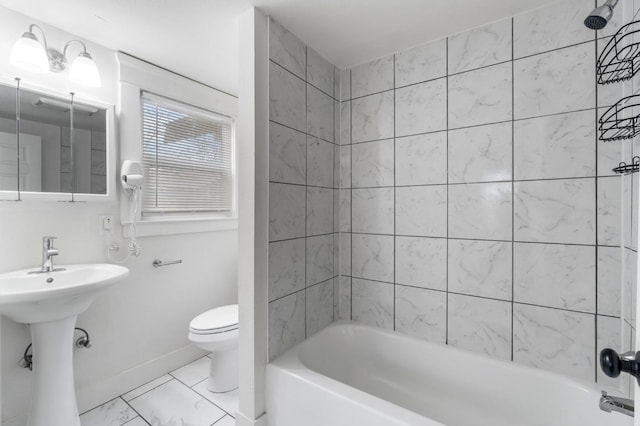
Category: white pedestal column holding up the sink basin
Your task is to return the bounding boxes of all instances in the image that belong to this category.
[27,315,80,426]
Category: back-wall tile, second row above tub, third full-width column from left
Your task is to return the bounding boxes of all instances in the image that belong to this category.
[447,239,512,300]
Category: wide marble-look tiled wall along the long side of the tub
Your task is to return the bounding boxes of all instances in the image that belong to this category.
[336,0,637,389]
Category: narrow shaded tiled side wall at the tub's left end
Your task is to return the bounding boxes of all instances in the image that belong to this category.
[269,20,339,359]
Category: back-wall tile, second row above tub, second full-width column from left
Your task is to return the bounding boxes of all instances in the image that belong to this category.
[395,236,447,290]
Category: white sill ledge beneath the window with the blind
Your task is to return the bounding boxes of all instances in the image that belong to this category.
[122,217,238,238]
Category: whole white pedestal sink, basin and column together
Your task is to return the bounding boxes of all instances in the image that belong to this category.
[0,264,129,426]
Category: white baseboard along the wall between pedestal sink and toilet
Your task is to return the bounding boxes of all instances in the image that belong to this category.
[76,345,206,413]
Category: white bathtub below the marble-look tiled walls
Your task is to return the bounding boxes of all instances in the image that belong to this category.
[266,323,633,426]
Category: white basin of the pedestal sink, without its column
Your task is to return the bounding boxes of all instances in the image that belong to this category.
[0,263,129,323]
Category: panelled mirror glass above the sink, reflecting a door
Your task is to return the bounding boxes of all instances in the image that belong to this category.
[0,80,107,195]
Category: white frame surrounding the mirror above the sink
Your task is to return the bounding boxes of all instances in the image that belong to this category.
[0,75,117,202]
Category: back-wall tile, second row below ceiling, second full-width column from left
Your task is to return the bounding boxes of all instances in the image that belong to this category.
[395,78,447,136]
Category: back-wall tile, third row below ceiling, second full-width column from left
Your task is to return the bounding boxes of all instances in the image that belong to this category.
[395,132,447,186]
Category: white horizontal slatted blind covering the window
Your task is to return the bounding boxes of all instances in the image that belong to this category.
[141,91,233,216]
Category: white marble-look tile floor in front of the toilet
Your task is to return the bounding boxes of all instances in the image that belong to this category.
[80,356,238,426]
